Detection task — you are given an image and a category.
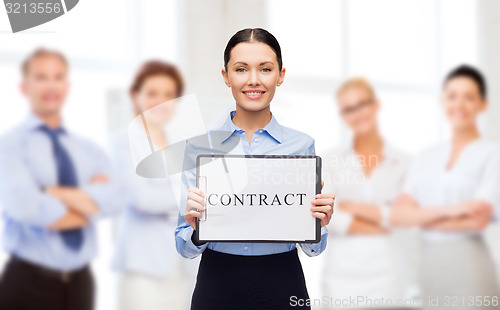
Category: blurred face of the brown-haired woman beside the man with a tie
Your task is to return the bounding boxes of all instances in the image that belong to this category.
[133,74,177,124]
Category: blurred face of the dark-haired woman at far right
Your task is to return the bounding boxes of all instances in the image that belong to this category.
[441,77,487,129]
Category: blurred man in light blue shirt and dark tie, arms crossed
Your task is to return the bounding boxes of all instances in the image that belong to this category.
[0,49,123,310]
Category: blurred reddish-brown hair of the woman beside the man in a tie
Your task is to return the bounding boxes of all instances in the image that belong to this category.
[130,60,184,114]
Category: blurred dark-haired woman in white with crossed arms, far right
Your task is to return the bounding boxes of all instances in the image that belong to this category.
[391,66,500,309]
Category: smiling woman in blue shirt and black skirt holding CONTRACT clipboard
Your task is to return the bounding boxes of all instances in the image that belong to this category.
[175,28,334,310]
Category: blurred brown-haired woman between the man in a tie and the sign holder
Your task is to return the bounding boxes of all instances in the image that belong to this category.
[112,61,197,310]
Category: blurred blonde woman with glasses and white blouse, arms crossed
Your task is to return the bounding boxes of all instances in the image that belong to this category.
[322,78,409,309]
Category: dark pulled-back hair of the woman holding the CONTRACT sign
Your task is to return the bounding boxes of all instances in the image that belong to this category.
[224,28,283,71]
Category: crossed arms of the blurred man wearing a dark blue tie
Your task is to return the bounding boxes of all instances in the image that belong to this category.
[0,135,126,230]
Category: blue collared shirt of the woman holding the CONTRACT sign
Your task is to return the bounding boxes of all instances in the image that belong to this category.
[175,111,328,258]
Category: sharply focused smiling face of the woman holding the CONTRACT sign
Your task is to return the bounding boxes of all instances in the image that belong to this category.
[222,42,285,112]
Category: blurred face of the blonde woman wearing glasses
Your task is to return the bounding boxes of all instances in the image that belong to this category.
[337,86,379,134]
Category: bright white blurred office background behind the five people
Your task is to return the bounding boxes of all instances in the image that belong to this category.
[0,0,500,310]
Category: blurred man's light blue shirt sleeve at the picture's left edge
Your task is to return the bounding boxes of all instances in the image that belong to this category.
[0,136,67,227]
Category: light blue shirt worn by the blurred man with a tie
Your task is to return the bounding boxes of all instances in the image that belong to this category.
[0,114,123,271]
